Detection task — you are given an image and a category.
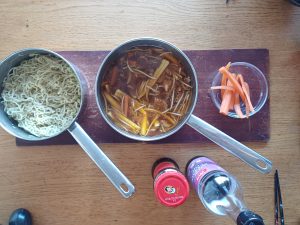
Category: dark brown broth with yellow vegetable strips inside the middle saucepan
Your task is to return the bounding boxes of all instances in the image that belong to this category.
[101,47,192,136]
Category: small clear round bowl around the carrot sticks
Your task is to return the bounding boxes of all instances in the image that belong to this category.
[210,62,268,118]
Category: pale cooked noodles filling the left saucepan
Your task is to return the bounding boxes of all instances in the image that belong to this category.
[1,55,80,137]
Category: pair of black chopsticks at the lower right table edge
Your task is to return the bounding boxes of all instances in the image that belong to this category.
[274,170,284,225]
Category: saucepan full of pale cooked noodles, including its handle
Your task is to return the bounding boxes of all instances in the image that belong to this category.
[0,49,134,197]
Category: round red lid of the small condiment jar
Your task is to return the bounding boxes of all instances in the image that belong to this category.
[154,169,190,207]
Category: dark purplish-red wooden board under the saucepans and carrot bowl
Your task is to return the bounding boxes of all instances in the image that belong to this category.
[16,49,270,146]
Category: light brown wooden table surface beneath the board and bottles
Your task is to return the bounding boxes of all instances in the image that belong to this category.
[0,0,300,225]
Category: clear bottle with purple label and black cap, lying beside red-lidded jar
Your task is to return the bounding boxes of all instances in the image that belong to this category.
[186,156,264,225]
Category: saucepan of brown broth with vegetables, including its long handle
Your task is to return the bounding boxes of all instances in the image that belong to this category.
[95,38,272,173]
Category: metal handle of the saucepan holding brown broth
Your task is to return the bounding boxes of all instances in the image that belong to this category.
[187,115,272,174]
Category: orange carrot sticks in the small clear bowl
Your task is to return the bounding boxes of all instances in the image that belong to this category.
[211,63,254,118]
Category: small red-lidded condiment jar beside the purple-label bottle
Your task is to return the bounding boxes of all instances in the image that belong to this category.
[152,158,190,207]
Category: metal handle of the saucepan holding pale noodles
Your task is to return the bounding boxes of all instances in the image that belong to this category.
[68,122,135,198]
